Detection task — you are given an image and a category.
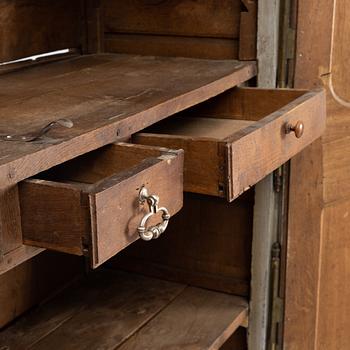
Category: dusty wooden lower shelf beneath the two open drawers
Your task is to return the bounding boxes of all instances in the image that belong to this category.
[0,270,248,350]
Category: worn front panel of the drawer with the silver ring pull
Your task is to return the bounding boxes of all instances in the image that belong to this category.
[89,153,183,267]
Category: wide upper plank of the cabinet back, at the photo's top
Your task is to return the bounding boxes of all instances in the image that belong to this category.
[102,0,241,38]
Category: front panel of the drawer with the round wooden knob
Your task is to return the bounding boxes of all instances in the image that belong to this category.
[226,91,326,200]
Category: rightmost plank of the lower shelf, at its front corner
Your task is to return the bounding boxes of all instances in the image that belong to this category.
[118,287,248,350]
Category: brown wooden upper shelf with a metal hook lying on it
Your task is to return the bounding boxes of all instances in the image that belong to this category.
[0,54,256,187]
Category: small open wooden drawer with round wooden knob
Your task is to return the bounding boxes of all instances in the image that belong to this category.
[133,87,326,201]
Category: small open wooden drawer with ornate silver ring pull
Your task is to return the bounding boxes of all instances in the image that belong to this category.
[19,143,183,267]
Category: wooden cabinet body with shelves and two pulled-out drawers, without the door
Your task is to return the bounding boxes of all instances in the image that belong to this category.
[0,0,326,350]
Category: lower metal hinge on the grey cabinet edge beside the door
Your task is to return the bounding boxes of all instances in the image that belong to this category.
[268,242,283,350]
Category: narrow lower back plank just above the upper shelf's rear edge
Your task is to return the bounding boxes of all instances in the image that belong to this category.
[105,33,238,60]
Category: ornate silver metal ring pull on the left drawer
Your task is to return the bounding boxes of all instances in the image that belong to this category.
[137,187,170,241]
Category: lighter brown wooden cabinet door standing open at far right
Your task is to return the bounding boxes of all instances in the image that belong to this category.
[284,0,350,350]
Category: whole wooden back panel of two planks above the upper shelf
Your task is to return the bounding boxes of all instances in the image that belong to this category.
[102,0,243,60]
